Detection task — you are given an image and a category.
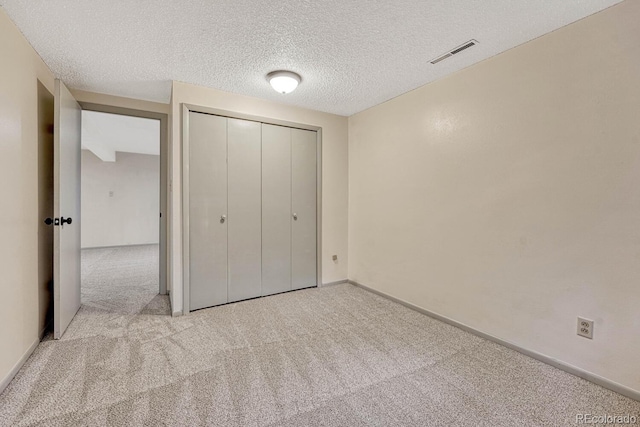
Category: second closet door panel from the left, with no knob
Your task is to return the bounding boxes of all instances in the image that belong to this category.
[227,119,262,302]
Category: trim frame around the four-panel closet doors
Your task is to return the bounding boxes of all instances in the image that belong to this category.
[182,103,322,315]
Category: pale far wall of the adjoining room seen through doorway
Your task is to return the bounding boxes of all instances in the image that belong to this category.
[81,150,160,248]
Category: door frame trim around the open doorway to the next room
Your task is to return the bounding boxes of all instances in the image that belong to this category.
[78,101,169,295]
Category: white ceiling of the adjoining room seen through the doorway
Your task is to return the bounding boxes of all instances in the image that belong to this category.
[82,110,160,162]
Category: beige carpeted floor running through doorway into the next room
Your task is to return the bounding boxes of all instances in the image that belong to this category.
[0,246,640,427]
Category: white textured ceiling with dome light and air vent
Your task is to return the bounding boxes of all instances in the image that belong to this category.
[0,0,620,115]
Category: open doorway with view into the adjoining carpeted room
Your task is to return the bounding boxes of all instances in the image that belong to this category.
[80,103,170,314]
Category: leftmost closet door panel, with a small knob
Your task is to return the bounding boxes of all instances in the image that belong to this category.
[189,112,227,310]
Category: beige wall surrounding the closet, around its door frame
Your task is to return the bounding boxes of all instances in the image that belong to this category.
[171,82,348,311]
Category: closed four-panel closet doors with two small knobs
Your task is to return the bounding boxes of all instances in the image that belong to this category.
[188,111,317,310]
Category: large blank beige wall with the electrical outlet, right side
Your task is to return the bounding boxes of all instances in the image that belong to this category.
[349,1,640,390]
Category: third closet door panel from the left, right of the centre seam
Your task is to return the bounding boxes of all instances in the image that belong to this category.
[262,124,292,295]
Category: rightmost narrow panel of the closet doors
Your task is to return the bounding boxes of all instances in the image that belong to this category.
[291,129,317,289]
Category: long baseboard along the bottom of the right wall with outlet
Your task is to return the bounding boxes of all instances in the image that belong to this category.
[349,280,640,401]
